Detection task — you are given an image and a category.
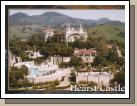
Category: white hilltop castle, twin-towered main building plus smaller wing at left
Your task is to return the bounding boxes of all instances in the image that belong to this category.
[43,24,88,43]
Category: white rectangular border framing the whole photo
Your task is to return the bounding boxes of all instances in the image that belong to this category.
[1,1,129,98]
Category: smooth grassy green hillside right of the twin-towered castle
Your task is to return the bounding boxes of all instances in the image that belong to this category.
[87,24,125,42]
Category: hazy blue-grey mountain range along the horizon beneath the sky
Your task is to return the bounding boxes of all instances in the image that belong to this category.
[10,12,124,26]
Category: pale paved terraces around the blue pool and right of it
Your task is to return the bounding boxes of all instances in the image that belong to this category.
[15,61,113,85]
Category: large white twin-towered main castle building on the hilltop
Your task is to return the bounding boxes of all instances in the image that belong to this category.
[65,25,87,42]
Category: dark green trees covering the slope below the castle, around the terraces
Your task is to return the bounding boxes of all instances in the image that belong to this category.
[9,32,125,88]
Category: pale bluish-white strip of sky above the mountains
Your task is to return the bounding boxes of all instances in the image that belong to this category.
[9,9,125,22]
